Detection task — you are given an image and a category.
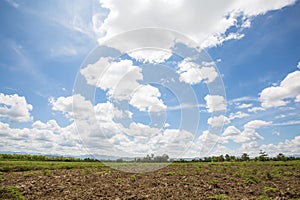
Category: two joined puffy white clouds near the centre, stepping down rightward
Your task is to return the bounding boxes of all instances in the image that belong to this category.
[80,58,166,112]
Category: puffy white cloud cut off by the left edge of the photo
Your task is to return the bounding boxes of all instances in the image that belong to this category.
[0,93,33,122]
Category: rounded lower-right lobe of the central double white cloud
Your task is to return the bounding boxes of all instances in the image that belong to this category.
[129,85,167,112]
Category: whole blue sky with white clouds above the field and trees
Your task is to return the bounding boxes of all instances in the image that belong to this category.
[0,0,300,158]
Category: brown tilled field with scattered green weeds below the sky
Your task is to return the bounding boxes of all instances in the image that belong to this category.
[0,160,300,199]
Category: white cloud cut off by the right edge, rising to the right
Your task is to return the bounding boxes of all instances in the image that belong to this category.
[259,71,300,108]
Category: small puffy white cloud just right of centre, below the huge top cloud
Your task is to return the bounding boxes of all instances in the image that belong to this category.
[177,58,218,84]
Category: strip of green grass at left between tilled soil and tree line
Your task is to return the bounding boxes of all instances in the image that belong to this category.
[0,160,104,172]
